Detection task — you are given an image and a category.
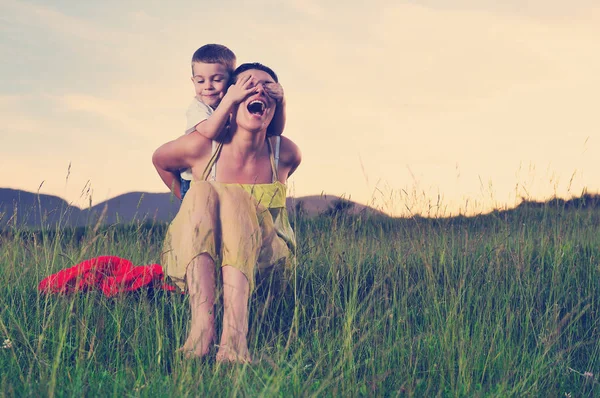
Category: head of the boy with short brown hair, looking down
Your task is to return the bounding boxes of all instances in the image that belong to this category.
[192,44,236,108]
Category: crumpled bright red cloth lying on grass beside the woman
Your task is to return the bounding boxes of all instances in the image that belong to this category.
[38,256,176,297]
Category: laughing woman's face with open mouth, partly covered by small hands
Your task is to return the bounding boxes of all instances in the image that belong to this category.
[235,69,277,132]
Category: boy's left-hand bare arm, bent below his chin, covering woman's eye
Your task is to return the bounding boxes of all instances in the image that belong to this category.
[196,76,256,140]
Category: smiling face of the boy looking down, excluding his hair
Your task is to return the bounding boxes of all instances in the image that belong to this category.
[192,62,229,108]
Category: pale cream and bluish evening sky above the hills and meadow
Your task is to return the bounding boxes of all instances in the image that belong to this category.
[0,0,600,216]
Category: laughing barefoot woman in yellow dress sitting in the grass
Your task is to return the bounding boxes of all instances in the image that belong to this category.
[153,63,301,362]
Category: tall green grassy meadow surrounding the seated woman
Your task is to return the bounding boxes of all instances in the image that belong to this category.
[0,197,600,397]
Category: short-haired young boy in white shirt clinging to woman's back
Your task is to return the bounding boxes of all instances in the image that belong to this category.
[178,44,285,200]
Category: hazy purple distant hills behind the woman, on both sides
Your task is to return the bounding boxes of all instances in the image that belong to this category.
[0,188,384,228]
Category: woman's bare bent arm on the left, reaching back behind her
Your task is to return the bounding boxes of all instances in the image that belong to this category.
[152,133,211,199]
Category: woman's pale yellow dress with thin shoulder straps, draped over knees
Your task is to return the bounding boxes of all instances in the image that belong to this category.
[161,137,296,292]
